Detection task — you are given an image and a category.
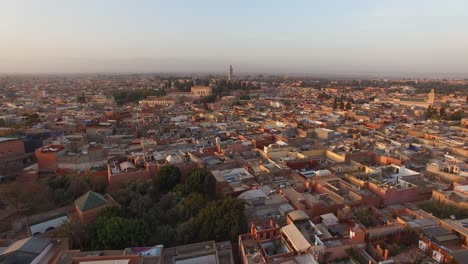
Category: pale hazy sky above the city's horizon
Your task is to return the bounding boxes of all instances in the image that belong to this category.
[0,0,468,76]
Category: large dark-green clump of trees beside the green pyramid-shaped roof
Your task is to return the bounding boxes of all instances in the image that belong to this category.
[59,166,246,250]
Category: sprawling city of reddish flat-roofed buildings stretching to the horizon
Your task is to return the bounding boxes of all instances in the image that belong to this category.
[0,72,468,264]
